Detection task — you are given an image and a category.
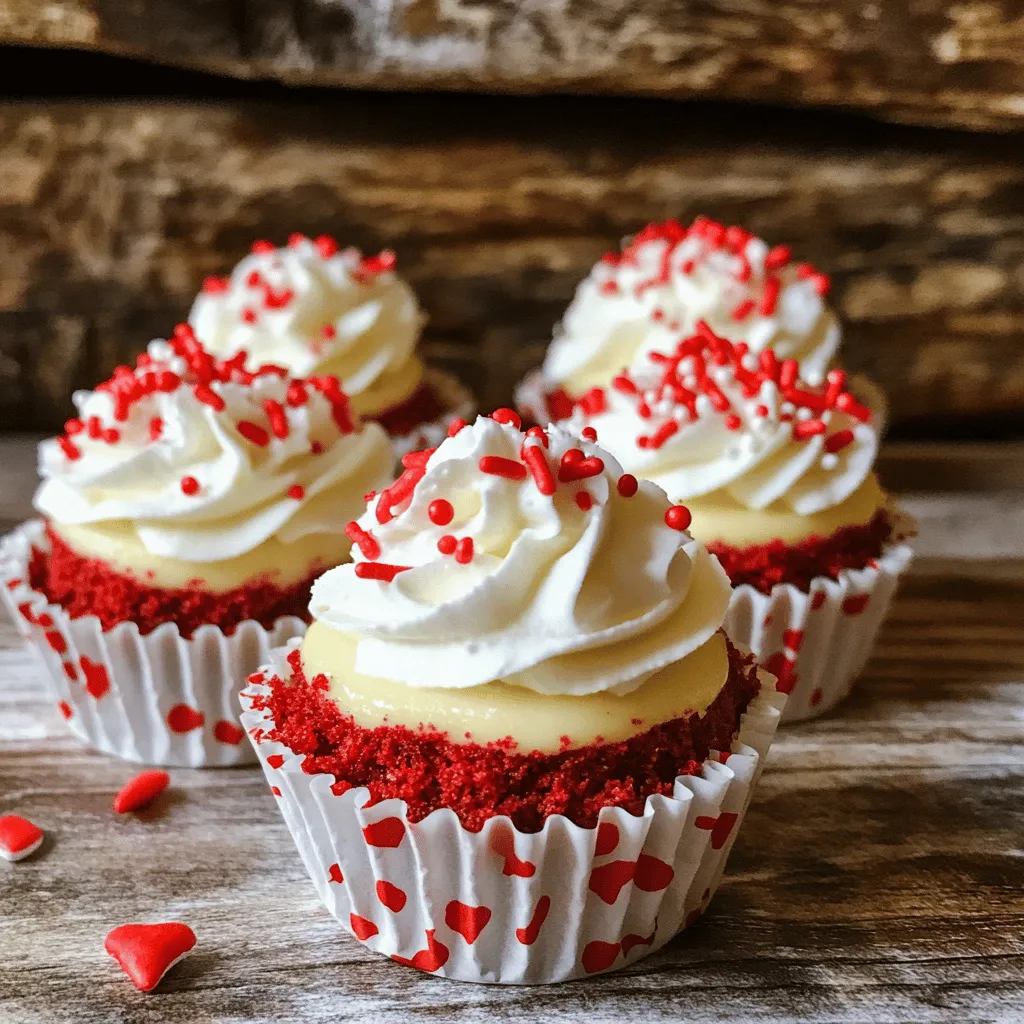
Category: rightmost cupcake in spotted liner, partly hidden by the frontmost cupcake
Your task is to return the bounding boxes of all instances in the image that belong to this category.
[570,322,910,721]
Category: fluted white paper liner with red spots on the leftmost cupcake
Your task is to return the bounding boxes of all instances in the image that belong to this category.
[0,519,306,768]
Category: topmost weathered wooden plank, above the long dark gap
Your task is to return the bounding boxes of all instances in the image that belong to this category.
[0,0,1024,129]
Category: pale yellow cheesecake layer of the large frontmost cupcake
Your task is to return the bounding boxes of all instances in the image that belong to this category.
[302,622,729,753]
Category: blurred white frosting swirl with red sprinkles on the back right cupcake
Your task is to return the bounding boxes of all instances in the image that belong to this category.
[542,218,841,393]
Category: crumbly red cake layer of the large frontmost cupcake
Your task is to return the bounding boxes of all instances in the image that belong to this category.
[254,644,760,833]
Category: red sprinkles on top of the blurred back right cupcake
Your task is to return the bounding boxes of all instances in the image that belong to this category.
[599,210,831,315]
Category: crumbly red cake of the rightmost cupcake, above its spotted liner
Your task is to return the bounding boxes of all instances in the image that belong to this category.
[706,509,893,594]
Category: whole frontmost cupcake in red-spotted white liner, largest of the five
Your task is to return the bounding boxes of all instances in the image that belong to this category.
[242,410,785,984]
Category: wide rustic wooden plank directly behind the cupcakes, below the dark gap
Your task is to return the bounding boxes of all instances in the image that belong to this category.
[0,93,1024,436]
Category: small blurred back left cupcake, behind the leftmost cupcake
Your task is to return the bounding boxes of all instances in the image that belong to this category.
[188,234,473,455]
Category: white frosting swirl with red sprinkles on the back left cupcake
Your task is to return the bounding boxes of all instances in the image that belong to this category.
[188,236,424,408]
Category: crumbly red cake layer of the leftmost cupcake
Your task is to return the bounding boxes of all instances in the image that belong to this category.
[29,526,315,640]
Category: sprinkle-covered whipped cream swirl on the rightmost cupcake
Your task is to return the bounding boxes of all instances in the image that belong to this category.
[569,325,879,515]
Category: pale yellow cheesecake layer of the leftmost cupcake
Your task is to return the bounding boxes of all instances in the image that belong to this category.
[50,520,351,593]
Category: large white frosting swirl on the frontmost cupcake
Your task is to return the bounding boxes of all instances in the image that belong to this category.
[310,418,730,694]
